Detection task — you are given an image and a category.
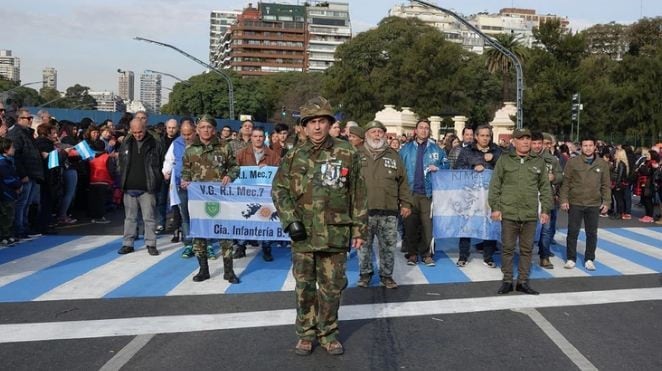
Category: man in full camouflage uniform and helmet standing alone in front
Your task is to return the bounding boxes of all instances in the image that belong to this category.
[272,97,368,355]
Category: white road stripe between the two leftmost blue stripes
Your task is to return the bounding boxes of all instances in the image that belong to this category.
[0,236,118,286]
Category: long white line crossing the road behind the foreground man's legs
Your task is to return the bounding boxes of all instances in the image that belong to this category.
[0,287,662,343]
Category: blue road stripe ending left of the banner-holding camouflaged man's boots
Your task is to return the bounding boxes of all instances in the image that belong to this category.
[104,246,198,298]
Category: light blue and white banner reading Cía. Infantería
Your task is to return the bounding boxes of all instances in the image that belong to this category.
[187,166,289,241]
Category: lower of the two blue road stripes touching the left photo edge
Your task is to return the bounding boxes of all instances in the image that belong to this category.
[0,239,121,302]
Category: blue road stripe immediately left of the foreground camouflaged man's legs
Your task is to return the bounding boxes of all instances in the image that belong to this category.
[225,247,292,294]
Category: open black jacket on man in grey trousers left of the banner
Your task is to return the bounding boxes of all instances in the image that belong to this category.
[118,132,165,193]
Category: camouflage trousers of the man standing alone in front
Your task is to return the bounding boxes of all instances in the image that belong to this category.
[292,252,347,344]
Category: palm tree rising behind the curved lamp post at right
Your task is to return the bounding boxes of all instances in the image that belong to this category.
[485,33,527,101]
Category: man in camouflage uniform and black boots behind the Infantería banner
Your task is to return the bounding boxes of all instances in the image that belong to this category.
[181,115,239,283]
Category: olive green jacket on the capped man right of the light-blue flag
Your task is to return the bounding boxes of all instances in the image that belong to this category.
[488,150,552,222]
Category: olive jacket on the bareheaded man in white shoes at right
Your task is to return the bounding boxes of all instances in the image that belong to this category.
[560,154,611,207]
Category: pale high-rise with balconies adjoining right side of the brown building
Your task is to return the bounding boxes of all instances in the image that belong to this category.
[306,1,352,71]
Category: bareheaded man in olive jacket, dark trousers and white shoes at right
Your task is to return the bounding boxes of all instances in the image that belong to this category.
[560,136,611,271]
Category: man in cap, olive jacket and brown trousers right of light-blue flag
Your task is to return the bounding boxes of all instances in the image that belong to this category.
[488,129,552,295]
